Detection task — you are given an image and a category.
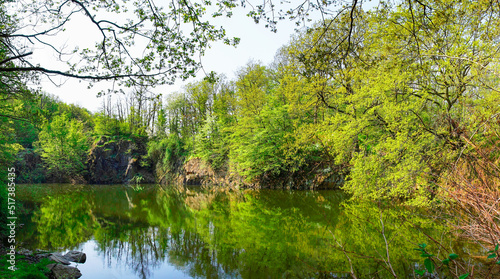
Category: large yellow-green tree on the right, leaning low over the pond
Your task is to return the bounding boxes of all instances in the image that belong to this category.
[286,1,499,203]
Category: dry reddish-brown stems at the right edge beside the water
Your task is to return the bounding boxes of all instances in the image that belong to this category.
[442,135,500,248]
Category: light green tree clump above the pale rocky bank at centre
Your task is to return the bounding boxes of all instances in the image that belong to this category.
[184,63,324,181]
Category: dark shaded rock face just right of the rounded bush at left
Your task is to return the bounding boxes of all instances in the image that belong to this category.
[87,137,155,184]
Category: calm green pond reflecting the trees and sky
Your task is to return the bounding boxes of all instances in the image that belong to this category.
[17,184,471,278]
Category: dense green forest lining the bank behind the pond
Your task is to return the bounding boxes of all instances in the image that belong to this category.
[0,0,500,278]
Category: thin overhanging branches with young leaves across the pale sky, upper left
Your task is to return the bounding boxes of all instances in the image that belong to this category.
[0,0,346,92]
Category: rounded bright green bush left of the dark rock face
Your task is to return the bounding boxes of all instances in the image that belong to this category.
[38,114,89,181]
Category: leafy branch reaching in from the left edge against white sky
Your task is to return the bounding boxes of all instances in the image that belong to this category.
[0,0,246,88]
